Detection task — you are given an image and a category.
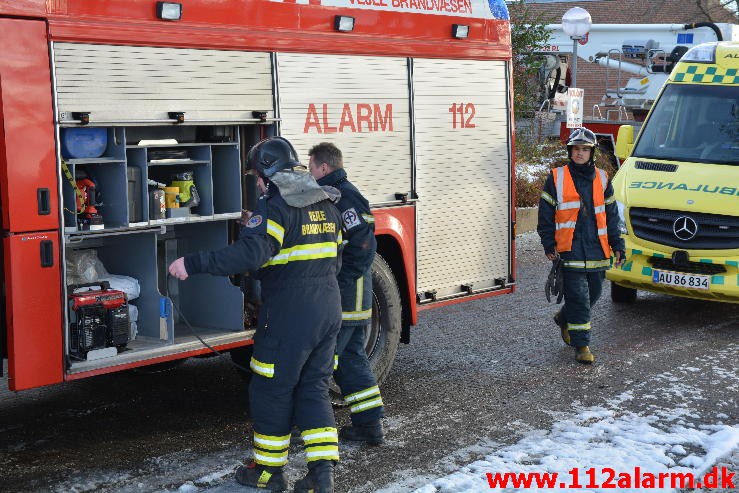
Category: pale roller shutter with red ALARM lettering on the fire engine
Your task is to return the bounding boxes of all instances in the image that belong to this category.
[278,53,411,204]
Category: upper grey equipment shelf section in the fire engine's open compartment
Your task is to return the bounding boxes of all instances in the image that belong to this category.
[62,127,241,229]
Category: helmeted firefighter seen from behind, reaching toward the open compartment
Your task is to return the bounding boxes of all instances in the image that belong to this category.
[169,133,342,493]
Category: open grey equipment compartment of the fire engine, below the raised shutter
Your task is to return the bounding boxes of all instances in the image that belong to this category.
[61,125,251,373]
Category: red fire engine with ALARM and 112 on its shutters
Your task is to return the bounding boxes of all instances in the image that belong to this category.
[0,0,515,390]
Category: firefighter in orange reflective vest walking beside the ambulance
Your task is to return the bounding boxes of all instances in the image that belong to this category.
[537,128,625,364]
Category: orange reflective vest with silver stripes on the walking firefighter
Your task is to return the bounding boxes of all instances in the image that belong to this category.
[552,166,611,258]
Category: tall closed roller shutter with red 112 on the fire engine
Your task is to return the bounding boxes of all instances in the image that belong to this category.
[413,59,511,299]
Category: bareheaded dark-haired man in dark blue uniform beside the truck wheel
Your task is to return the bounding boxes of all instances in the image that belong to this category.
[308,142,384,445]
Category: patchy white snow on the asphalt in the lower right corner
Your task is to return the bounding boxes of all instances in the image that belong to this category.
[381,344,739,493]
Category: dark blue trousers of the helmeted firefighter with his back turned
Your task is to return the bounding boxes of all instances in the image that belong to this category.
[249,283,341,467]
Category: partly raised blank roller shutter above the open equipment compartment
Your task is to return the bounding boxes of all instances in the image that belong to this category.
[53,43,274,123]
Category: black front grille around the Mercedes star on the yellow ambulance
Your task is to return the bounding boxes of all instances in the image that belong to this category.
[629,207,739,250]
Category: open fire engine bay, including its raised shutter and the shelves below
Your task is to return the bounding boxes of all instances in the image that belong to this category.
[51,42,274,374]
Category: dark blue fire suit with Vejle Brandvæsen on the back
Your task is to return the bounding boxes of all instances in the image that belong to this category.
[185,180,342,466]
